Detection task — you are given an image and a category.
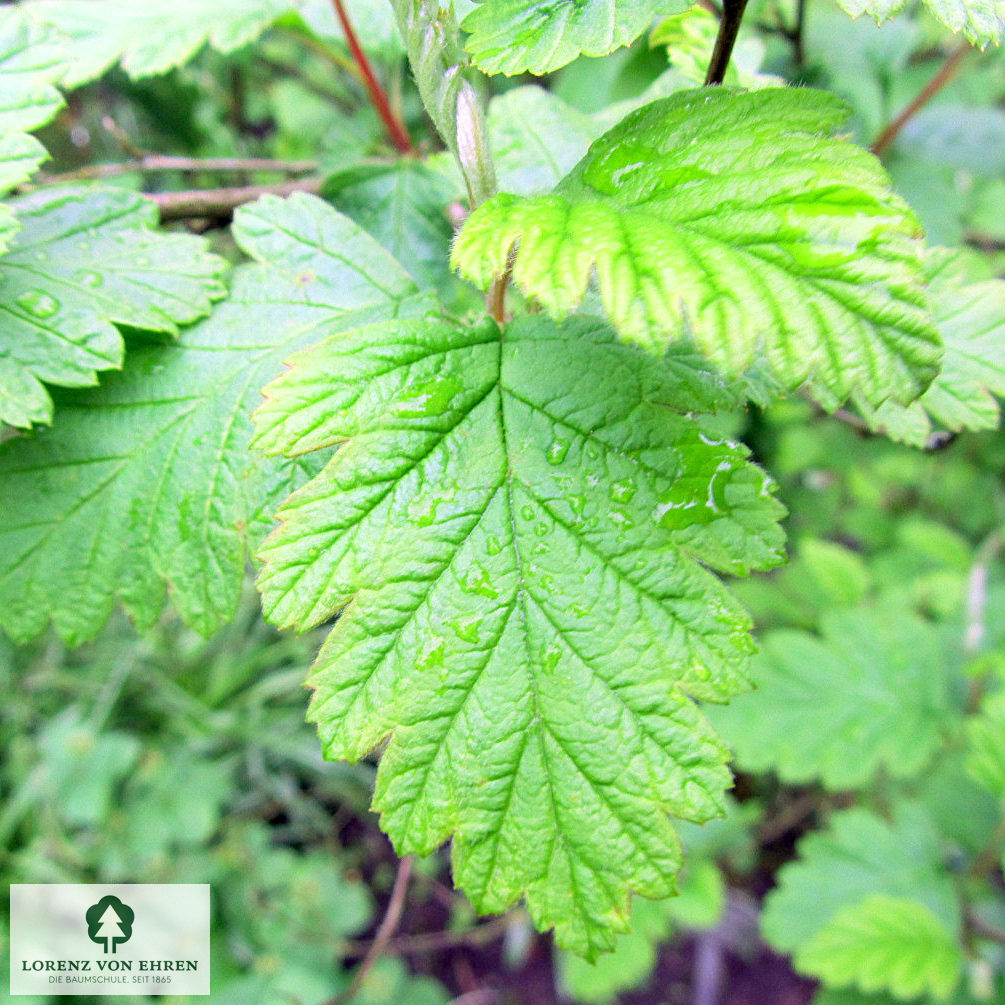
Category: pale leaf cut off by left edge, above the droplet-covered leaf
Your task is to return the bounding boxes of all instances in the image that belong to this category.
[0,7,65,251]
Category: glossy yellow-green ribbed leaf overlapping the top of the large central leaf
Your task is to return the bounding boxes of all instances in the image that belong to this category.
[453,87,940,403]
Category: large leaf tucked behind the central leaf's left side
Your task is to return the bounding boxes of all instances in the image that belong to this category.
[0,189,428,642]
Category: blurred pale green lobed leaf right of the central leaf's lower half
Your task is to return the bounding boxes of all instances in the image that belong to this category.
[712,607,958,790]
